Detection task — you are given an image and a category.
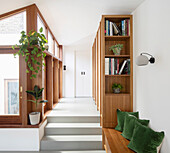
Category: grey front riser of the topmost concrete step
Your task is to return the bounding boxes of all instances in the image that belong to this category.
[47,115,100,123]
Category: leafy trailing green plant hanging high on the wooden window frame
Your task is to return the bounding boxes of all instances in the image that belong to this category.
[12,27,48,79]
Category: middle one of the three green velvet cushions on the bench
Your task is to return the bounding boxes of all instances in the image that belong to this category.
[121,114,149,140]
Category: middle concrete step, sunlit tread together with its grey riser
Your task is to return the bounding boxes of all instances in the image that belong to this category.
[45,123,102,135]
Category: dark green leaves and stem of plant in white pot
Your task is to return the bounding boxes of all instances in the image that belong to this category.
[26,85,48,112]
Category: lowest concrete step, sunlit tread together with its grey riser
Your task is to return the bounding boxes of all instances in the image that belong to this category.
[41,135,102,151]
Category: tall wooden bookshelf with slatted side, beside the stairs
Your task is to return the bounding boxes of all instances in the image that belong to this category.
[92,15,133,128]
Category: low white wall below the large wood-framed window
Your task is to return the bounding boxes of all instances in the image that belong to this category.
[0,120,47,152]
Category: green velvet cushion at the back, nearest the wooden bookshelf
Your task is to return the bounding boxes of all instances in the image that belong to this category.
[115,109,139,132]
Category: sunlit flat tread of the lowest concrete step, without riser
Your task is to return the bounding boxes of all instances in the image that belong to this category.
[42,135,102,141]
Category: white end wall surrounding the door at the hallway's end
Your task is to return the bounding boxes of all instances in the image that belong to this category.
[63,35,94,97]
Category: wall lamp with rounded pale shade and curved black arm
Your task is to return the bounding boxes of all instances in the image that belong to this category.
[136,53,155,66]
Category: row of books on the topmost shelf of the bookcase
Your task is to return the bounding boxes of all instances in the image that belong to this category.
[105,19,130,36]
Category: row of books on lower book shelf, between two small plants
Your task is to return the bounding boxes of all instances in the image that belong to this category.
[105,58,130,75]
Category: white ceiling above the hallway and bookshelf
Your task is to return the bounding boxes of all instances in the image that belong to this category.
[0,0,144,45]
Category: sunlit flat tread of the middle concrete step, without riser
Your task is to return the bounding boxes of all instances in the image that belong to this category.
[45,123,101,129]
